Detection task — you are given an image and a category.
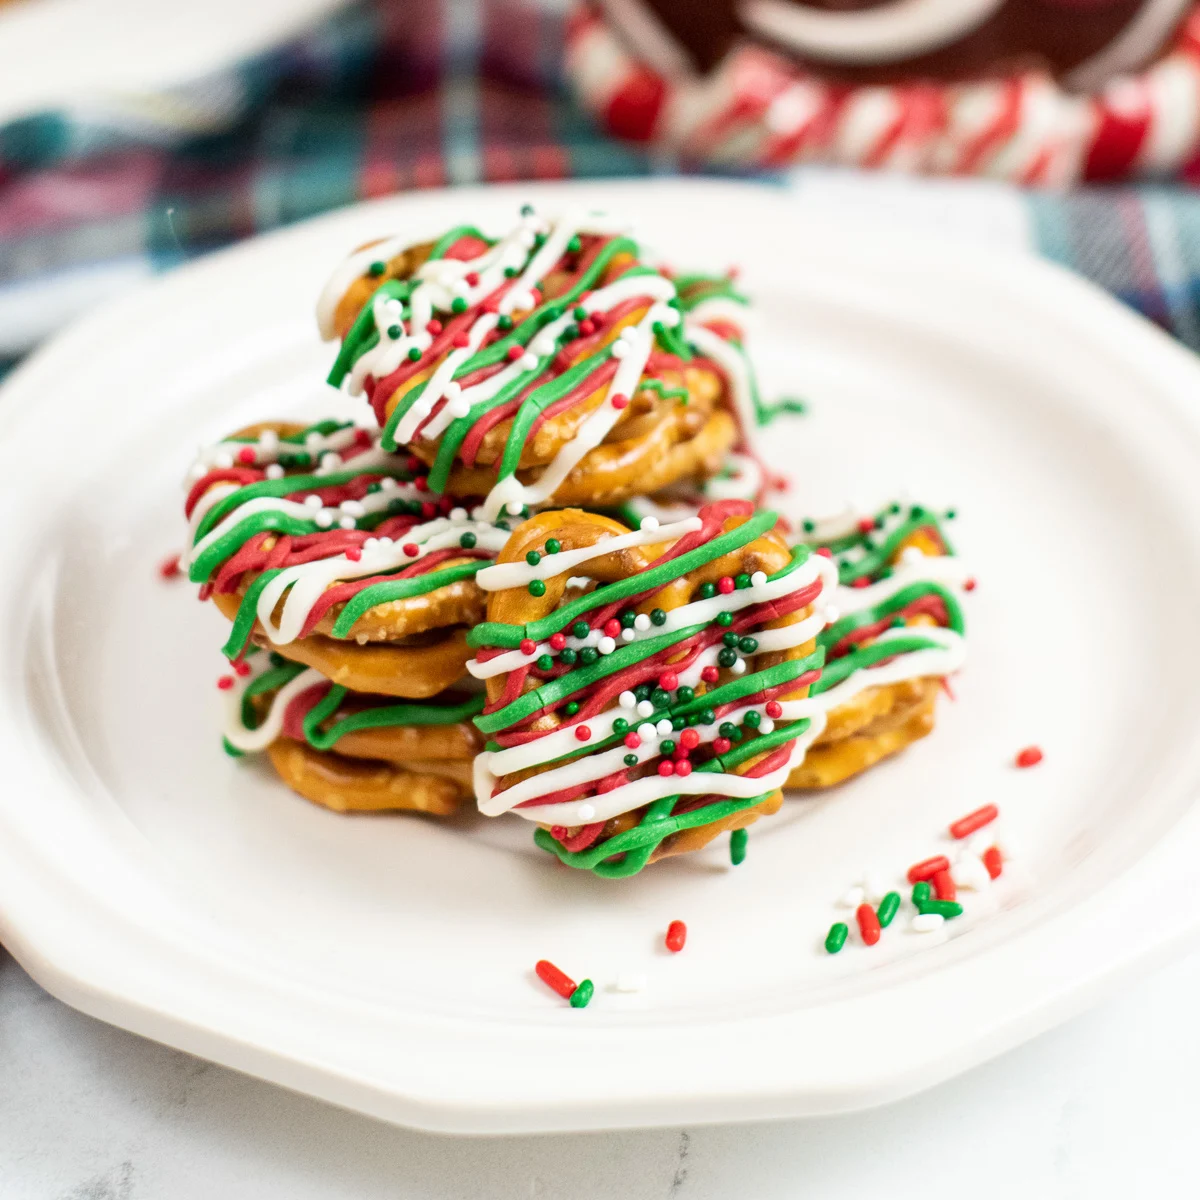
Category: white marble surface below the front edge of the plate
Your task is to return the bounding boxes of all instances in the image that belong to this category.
[0,954,1200,1200]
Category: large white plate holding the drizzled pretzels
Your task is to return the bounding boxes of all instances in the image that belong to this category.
[0,181,1200,1132]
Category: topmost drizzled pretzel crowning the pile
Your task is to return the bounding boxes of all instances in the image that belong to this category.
[318,210,764,518]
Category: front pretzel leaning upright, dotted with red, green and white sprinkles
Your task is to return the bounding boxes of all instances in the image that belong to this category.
[468,500,834,877]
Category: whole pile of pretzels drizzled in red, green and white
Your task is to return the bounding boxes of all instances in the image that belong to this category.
[187,208,970,876]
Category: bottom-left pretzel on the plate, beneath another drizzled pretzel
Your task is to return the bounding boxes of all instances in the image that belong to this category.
[226,655,482,816]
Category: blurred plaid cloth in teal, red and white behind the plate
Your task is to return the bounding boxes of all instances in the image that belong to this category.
[0,0,1200,373]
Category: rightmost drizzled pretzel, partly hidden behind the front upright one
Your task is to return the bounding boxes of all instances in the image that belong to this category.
[787,504,968,790]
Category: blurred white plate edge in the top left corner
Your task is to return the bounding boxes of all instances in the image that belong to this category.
[0,0,346,127]
